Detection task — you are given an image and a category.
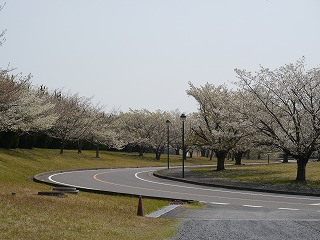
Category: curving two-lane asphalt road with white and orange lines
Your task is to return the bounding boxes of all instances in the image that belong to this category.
[35,167,320,216]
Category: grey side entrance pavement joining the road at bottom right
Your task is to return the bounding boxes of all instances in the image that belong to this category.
[164,205,320,240]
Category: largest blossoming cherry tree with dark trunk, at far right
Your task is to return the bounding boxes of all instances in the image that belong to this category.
[235,58,320,181]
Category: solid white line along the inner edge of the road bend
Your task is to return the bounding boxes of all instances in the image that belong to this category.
[135,170,319,201]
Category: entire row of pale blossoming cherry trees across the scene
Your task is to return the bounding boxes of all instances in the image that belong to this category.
[0,58,320,181]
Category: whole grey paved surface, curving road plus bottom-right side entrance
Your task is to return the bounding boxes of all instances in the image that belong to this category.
[43,167,320,239]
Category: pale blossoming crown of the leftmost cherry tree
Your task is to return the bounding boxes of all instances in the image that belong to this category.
[0,70,56,133]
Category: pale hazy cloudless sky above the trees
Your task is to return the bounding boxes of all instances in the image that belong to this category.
[0,0,320,113]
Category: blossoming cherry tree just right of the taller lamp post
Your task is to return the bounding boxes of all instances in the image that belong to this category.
[187,83,248,171]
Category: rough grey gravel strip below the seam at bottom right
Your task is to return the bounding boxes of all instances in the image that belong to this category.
[170,220,320,240]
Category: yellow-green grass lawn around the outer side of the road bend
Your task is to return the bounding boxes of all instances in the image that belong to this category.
[0,149,212,240]
